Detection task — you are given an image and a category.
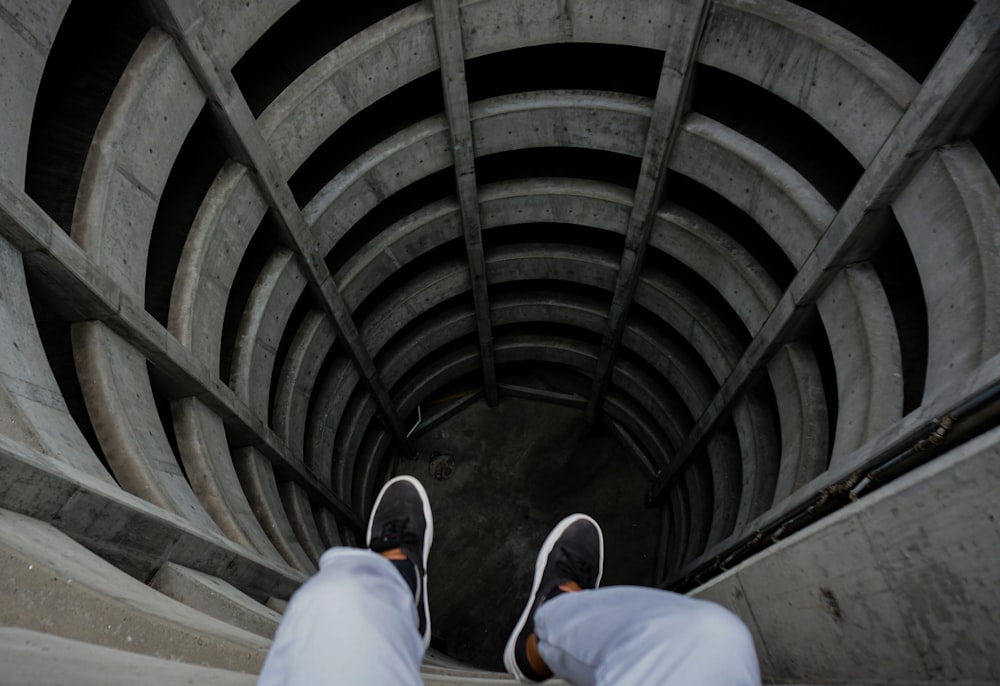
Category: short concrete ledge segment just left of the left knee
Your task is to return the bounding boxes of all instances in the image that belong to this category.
[149,562,281,638]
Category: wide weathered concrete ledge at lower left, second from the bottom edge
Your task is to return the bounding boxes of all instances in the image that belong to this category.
[0,511,269,672]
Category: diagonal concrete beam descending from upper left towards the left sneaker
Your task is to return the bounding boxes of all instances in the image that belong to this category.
[147,0,412,454]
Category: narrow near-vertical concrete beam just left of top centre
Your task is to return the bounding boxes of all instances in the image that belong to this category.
[433,0,497,407]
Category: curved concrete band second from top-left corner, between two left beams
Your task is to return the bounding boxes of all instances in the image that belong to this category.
[72,29,205,303]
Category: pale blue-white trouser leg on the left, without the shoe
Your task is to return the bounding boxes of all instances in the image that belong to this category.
[257,548,424,686]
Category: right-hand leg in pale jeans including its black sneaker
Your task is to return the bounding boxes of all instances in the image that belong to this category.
[504,515,760,686]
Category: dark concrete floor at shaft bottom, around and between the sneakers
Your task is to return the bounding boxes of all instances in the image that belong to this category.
[396,398,659,671]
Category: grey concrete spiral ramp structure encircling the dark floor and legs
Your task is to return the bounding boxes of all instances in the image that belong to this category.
[0,0,1000,683]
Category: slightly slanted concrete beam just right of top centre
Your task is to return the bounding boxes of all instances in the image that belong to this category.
[586,0,708,424]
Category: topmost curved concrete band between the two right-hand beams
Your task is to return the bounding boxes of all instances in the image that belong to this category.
[697,0,918,165]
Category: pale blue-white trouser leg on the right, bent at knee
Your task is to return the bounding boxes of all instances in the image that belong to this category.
[535,586,761,686]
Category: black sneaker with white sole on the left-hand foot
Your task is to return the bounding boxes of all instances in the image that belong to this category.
[366,476,434,649]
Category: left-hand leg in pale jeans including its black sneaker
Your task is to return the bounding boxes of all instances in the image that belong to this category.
[258,476,434,686]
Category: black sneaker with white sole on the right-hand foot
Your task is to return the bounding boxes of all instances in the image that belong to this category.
[503,514,604,681]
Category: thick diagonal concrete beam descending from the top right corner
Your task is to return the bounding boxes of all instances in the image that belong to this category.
[650,2,1000,502]
